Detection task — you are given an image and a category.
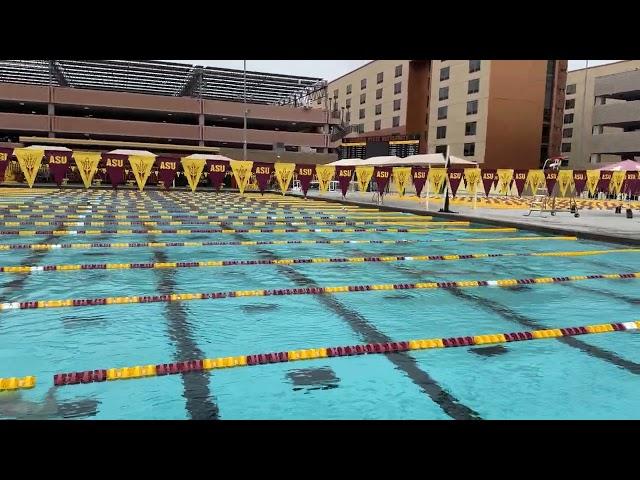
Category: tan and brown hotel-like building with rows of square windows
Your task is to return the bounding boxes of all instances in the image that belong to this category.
[316,60,567,168]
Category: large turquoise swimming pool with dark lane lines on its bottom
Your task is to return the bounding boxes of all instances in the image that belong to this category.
[0,190,640,419]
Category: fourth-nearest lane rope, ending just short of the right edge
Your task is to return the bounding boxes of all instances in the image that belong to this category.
[0,236,578,251]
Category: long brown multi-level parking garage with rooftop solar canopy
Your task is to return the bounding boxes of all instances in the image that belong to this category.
[0,60,340,163]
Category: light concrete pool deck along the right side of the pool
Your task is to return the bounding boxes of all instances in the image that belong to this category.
[291,192,640,245]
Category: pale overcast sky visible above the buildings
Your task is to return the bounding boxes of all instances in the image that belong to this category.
[169,60,617,81]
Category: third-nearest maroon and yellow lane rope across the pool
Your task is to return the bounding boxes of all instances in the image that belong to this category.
[0,248,640,273]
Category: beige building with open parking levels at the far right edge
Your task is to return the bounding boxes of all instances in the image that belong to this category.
[561,60,640,168]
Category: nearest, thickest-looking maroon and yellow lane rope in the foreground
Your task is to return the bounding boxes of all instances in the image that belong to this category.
[53,321,640,387]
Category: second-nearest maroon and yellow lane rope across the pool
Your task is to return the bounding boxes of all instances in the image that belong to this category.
[0,272,640,310]
